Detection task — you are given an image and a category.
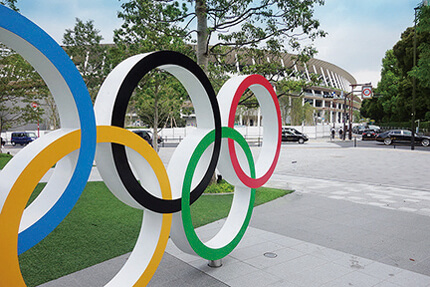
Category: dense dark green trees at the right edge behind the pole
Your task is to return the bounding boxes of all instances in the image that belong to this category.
[361,6,430,126]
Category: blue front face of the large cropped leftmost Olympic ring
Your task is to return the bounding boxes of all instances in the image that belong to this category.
[0,5,96,255]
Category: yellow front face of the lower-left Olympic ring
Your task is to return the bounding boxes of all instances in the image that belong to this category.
[0,126,172,287]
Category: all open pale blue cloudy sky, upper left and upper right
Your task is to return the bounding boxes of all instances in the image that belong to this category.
[14,0,421,89]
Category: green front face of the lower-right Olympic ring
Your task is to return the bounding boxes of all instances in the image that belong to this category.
[181,127,255,260]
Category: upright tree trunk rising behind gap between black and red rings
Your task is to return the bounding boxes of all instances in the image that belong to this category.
[195,0,209,72]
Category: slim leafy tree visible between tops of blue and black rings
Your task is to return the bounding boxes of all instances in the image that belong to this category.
[63,18,107,101]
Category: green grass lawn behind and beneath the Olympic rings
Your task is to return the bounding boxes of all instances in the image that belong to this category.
[19,182,291,286]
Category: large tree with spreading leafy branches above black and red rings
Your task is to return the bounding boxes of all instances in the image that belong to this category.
[115,0,325,148]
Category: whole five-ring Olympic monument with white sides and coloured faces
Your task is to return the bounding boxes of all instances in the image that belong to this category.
[0,5,281,287]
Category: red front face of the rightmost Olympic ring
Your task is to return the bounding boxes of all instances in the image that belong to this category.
[228,75,282,188]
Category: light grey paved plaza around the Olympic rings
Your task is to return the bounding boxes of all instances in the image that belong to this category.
[26,140,430,287]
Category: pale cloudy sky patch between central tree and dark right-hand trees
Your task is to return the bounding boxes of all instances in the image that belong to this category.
[314,0,416,86]
